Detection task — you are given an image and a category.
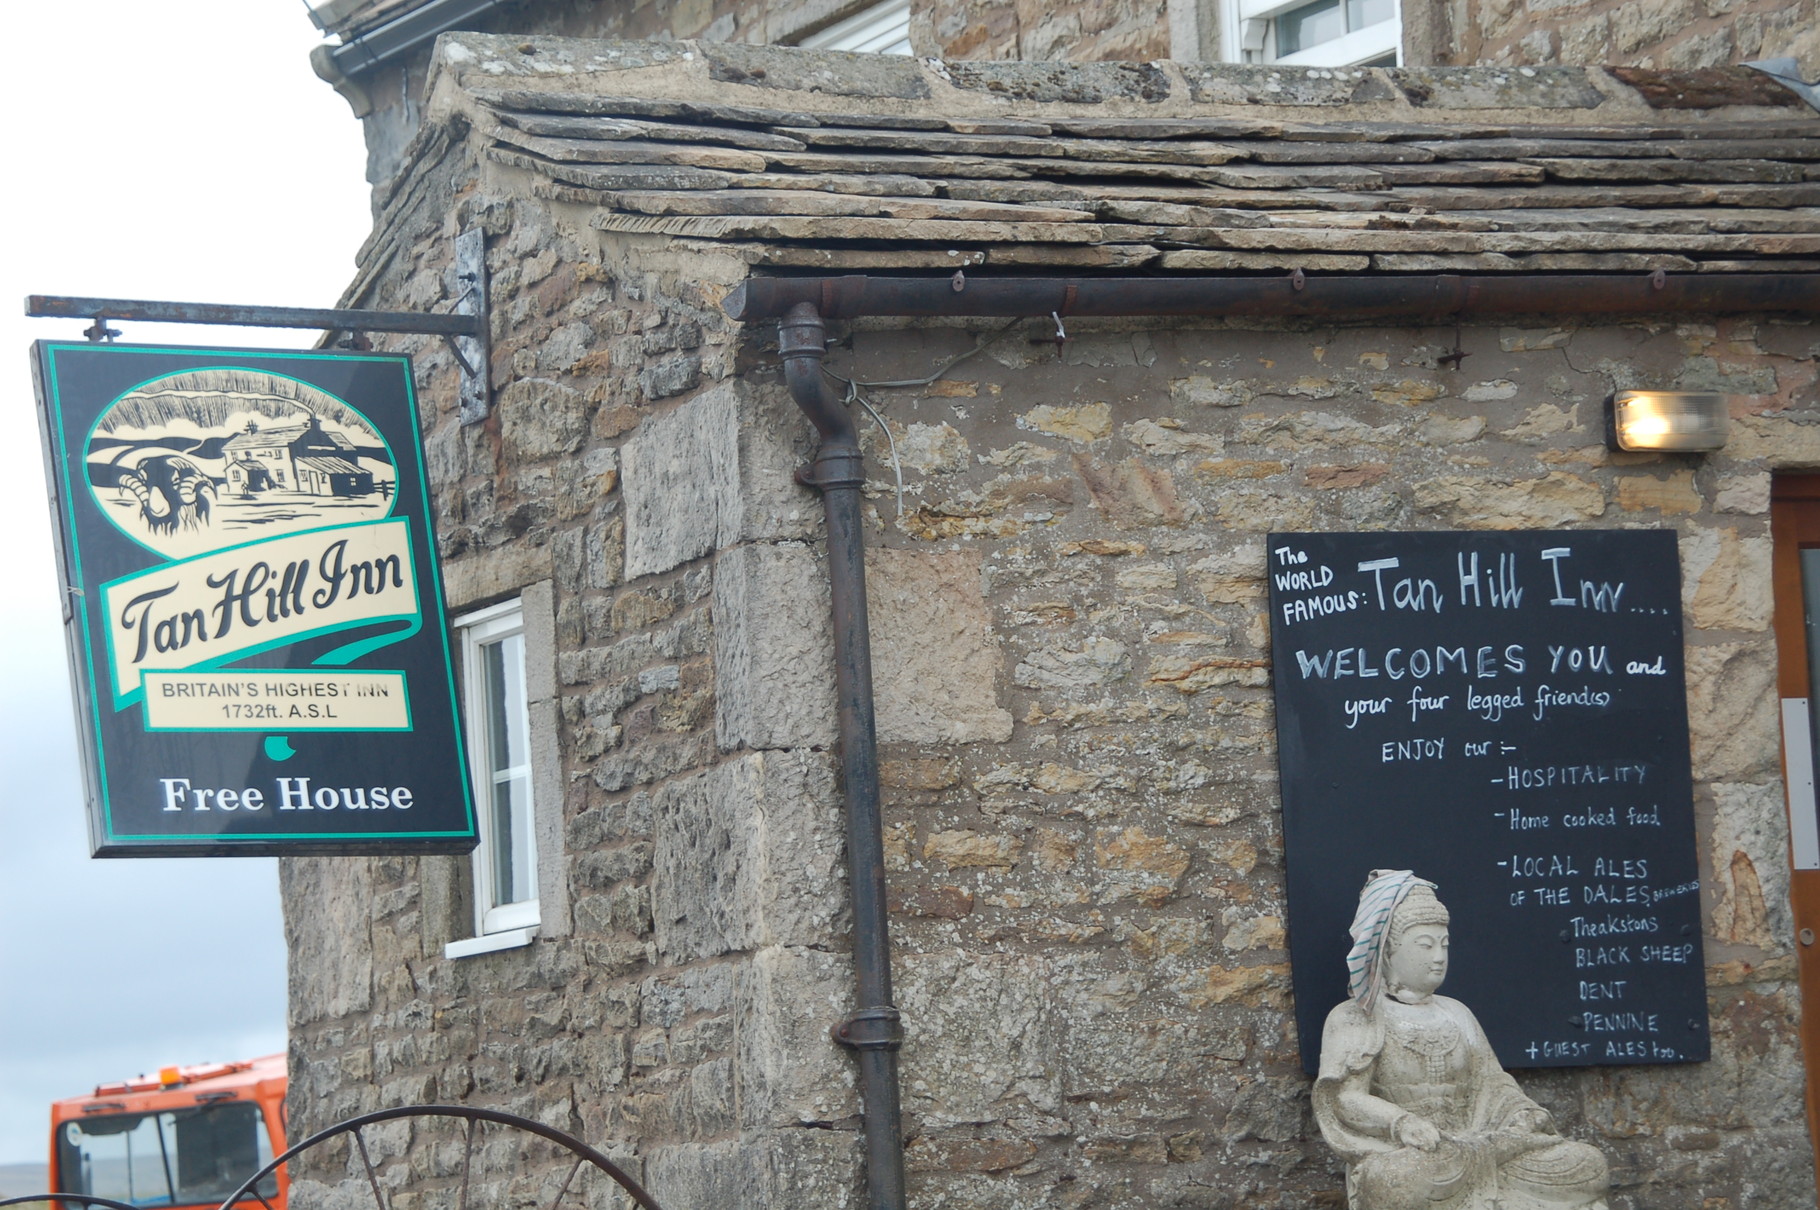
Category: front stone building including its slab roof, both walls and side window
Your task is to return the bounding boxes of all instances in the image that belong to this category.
[269,18,1820,1210]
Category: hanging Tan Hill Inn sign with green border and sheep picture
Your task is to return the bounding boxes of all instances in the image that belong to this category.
[35,340,475,857]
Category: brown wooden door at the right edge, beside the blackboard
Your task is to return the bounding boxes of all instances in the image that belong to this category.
[1769,475,1820,1154]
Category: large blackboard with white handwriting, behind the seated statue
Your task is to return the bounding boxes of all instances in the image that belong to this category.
[1269,531,1709,1072]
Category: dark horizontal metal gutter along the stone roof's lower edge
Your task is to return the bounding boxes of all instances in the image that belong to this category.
[721,269,1820,322]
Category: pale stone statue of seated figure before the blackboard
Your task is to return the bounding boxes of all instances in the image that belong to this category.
[1314,870,1609,1210]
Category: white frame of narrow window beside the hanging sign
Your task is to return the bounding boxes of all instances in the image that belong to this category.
[444,600,542,957]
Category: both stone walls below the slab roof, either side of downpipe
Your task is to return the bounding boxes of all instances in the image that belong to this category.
[282,115,1820,1210]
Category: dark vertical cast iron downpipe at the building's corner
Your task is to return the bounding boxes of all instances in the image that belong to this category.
[777,302,905,1210]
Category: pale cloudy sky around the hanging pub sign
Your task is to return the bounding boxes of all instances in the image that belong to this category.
[0,0,368,1163]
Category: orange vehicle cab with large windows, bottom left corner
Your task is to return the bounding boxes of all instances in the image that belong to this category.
[51,1055,289,1210]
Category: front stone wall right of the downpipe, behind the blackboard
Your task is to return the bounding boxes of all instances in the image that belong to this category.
[815,312,1820,1206]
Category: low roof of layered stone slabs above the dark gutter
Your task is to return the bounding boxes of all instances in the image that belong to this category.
[416,35,1820,273]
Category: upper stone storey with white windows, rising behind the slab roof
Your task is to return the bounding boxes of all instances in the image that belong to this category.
[313,0,1820,186]
